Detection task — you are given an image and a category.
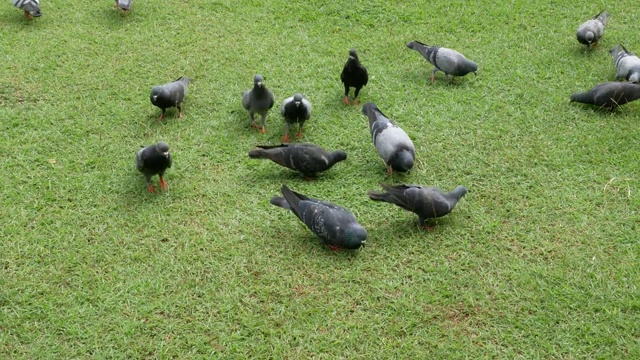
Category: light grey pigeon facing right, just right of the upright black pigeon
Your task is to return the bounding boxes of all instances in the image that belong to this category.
[407,41,478,83]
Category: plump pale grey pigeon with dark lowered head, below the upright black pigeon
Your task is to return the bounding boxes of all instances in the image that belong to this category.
[362,102,416,174]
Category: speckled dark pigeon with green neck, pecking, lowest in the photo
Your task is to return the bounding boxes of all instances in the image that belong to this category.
[270,185,367,251]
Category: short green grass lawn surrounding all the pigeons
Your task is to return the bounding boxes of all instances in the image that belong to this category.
[0,0,640,359]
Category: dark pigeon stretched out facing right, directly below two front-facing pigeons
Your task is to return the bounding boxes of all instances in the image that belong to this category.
[249,143,347,179]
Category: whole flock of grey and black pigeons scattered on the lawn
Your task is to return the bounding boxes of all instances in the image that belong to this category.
[12,4,640,250]
